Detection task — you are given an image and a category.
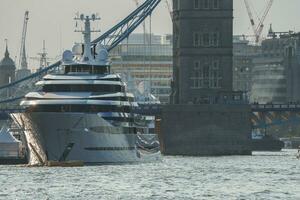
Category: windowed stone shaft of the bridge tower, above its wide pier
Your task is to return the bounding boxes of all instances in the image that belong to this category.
[172,0,233,104]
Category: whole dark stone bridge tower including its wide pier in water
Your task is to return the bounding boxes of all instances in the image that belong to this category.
[160,0,251,156]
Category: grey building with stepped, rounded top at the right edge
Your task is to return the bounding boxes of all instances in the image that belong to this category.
[250,32,300,103]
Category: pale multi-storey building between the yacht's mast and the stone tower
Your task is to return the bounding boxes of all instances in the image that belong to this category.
[110,33,173,103]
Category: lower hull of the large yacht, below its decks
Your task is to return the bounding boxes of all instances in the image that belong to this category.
[12,112,161,164]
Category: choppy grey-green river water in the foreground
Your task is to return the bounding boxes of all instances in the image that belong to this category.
[0,151,300,200]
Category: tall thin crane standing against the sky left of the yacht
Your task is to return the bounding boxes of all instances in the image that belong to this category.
[19,11,29,69]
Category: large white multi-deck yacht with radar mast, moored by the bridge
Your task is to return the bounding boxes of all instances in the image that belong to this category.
[13,15,160,164]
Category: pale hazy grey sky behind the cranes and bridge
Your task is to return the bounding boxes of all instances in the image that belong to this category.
[0,0,300,69]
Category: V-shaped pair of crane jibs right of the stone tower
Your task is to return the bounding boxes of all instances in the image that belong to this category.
[244,0,274,44]
